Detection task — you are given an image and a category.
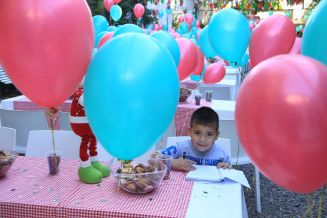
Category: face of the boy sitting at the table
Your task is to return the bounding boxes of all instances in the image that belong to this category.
[189,124,219,152]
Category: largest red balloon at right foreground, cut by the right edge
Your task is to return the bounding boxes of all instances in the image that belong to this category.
[235,54,327,193]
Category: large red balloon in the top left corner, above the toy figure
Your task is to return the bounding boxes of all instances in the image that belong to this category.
[0,0,94,107]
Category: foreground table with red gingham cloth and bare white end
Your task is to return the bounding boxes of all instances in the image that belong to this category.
[0,157,247,217]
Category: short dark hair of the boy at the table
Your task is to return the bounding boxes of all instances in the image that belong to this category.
[190,107,219,131]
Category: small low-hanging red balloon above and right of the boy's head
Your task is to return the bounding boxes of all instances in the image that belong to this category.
[203,63,226,84]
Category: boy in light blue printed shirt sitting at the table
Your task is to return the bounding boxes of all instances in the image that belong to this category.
[162,107,231,171]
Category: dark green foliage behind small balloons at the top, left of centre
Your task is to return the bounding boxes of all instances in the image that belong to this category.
[87,0,157,26]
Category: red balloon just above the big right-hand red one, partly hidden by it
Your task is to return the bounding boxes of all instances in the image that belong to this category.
[249,14,296,66]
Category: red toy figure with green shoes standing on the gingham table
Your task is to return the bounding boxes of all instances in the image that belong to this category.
[69,80,110,184]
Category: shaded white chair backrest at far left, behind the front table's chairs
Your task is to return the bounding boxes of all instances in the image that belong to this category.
[0,109,48,153]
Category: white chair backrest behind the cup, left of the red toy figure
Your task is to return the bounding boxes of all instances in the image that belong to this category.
[26,130,81,160]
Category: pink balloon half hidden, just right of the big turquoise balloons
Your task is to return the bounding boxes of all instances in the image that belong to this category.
[176,38,198,81]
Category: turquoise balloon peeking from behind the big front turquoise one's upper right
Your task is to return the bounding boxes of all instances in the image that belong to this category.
[151,31,181,66]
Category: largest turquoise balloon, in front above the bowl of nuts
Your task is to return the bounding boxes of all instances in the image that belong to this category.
[84,33,179,160]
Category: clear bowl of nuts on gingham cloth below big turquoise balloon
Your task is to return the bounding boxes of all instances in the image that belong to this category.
[109,159,167,194]
